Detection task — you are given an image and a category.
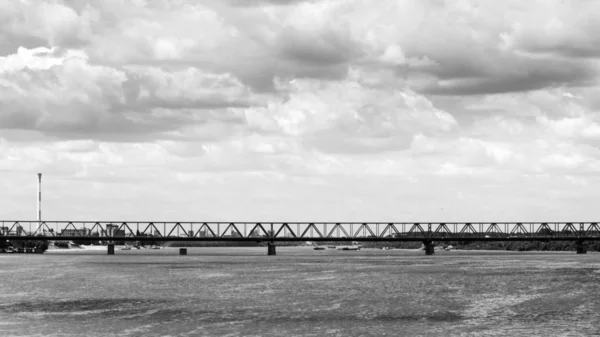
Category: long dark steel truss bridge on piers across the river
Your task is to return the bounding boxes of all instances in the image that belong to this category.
[0,220,600,255]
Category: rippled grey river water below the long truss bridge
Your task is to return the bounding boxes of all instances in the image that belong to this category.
[0,247,600,336]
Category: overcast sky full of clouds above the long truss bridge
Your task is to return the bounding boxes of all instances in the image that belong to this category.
[0,0,600,222]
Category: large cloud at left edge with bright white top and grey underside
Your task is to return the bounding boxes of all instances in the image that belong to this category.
[0,48,252,139]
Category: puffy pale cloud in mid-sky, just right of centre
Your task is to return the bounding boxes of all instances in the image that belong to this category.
[246,75,457,152]
